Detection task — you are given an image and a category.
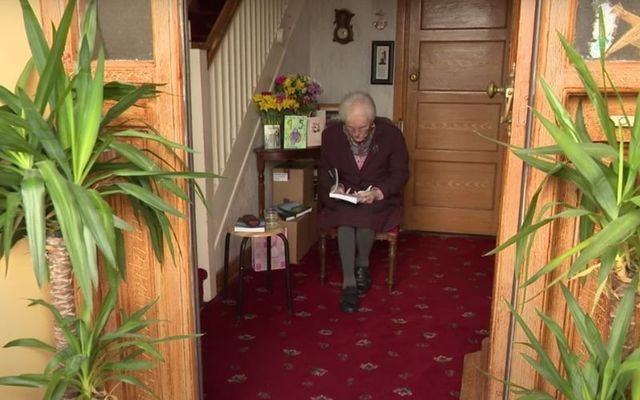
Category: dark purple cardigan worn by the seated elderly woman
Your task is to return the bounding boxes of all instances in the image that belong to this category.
[318,118,409,232]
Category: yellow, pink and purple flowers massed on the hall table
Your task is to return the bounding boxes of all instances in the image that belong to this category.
[253,75,322,125]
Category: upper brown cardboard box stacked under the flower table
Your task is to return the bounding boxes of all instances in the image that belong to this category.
[271,161,314,205]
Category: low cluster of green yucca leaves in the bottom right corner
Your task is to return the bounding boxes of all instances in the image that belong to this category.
[510,276,640,400]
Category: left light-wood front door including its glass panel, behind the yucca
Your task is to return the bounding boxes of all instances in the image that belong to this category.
[40,0,198,400]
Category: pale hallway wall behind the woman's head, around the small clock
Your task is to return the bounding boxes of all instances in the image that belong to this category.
[307,0,397,118]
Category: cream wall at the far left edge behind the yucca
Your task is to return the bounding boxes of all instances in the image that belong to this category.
[0,0,53,400]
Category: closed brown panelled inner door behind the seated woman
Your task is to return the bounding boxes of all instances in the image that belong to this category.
[400,0,512,235]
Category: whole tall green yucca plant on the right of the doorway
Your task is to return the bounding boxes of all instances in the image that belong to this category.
[484,10,640,400]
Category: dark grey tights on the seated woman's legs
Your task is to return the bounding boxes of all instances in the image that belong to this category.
[338,226,376,288]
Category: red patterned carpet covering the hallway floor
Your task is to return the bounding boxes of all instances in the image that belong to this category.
[201,233,494,400]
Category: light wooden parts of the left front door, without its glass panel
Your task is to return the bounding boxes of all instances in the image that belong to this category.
[40,0,200,400]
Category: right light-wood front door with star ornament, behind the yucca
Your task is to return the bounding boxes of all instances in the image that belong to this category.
[482,0,640,399]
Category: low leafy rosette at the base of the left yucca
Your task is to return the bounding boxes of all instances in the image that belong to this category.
[0,289,193,400]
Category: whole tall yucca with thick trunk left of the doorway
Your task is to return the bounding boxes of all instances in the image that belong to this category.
[0,0,215,399]
